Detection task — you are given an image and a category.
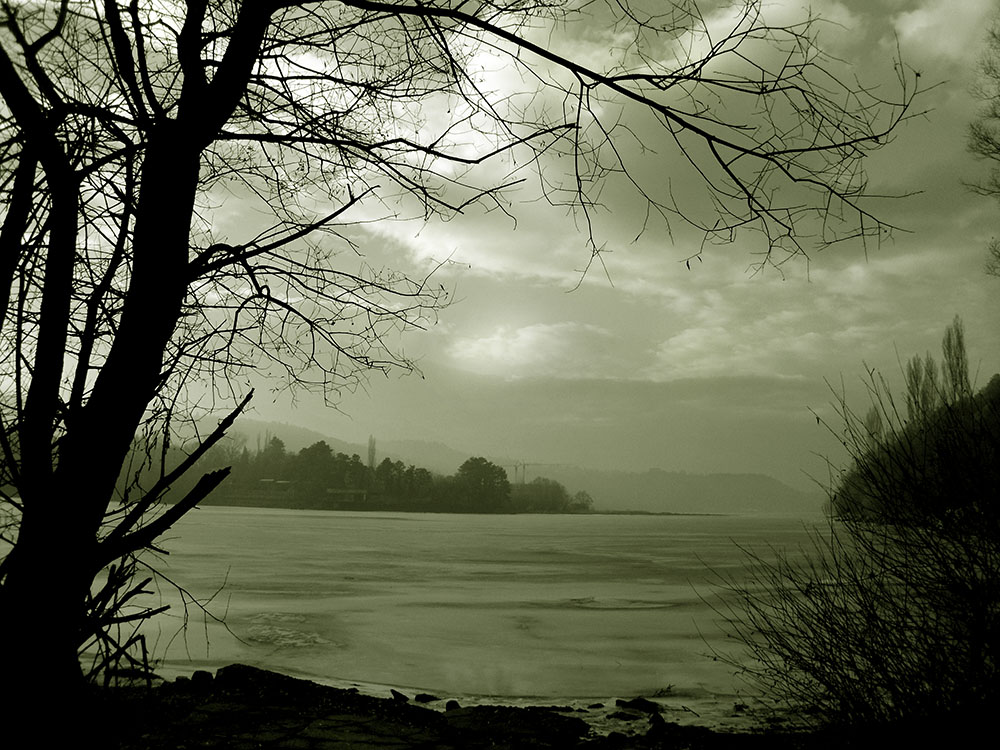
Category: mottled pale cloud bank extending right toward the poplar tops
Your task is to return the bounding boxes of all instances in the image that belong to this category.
[632,235,995,382]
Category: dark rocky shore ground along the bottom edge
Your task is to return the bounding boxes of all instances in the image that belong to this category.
[99,665,868,750]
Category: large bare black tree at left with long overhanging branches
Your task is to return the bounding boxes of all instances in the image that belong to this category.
[0,0,915,724]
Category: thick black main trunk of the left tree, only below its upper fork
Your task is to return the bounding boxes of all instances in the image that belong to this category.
[0,132,205,724]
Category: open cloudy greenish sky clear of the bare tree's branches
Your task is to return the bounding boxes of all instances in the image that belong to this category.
[238,0,1000,494]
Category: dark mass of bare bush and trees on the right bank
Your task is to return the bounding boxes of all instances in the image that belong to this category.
[730,319,1000,739]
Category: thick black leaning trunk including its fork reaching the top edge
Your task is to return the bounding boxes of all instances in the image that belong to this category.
[0,2,277,724]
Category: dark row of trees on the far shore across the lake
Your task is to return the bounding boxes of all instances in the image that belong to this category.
[166,437,593,513]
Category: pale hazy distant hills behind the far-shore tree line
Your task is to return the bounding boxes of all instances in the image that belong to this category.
[233,419,825,513]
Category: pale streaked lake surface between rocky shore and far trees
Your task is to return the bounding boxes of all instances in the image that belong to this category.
[131,508,819,716]
